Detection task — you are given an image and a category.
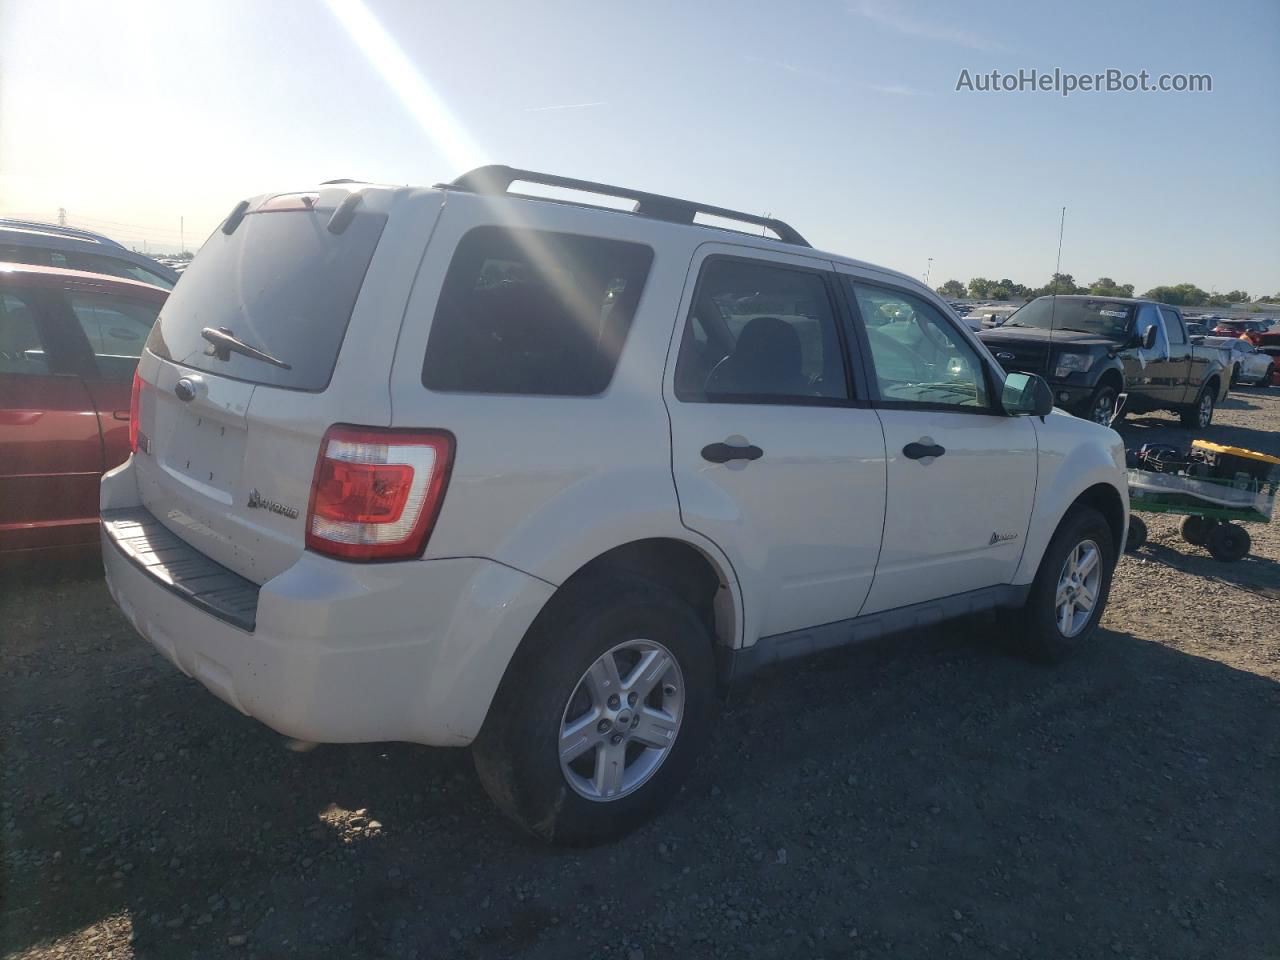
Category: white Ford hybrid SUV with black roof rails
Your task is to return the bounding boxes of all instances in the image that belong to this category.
[101,166,1128,844]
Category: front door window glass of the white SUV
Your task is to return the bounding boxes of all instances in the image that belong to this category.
[850,283,991,408]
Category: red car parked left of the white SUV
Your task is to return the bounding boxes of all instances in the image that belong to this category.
[0,262,169,558]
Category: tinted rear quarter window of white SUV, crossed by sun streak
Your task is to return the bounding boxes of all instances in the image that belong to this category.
[424,227,653,397]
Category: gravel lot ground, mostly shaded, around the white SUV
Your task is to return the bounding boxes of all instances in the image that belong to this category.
[0,389,1280,960]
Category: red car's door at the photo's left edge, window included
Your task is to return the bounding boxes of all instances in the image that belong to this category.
[0,283,102,553]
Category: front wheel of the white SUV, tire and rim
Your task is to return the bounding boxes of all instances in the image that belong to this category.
[1006,506,1116,663]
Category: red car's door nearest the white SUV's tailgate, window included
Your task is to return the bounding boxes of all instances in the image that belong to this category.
[63,289,163,470]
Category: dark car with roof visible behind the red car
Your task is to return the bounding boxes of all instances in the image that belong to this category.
[0,220,178,291]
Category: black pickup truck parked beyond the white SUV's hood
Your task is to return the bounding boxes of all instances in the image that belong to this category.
[978,296,1230,429]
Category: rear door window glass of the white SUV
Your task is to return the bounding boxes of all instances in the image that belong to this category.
[676,259,849,403]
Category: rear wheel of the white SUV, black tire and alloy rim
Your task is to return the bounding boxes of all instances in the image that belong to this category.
[472,577,718,846]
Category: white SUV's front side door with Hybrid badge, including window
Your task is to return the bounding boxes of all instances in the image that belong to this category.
[844,270,1037,613]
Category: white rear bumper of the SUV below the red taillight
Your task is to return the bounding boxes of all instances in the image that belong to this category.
[102,463,554,746]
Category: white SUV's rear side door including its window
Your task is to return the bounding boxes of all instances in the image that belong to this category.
[664,244,886,641]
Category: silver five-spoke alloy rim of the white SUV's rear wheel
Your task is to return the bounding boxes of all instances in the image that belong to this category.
[559,640,685,801]
